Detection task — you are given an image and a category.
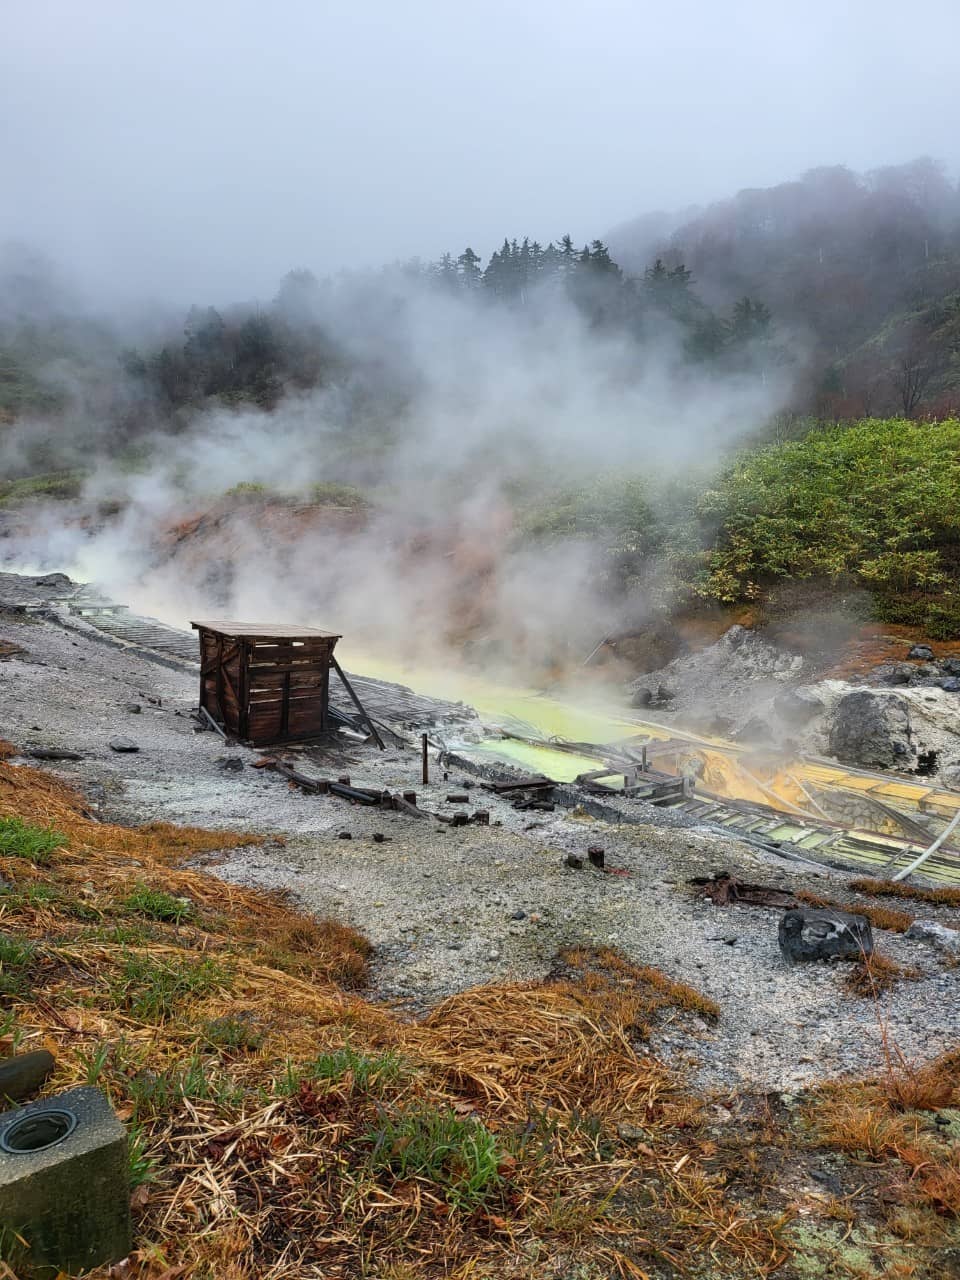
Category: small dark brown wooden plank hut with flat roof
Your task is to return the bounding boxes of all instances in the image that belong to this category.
[191,622,340,746]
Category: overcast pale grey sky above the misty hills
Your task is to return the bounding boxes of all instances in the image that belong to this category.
[0,0,960,302]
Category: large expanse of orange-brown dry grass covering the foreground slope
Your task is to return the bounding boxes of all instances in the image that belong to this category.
[0,763,786,1280]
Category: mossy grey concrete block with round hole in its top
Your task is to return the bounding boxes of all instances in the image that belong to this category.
[0,1088,131,1277]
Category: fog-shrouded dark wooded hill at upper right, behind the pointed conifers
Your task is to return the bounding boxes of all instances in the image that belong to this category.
[608,157,960,419]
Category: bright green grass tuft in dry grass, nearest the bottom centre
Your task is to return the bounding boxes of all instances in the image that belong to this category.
[365,1108,507,1213]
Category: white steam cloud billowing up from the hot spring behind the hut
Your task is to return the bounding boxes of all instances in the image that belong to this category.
[4,264,788,675]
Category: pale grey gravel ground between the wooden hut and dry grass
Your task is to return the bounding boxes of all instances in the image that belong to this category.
[0,604,960,1089]
